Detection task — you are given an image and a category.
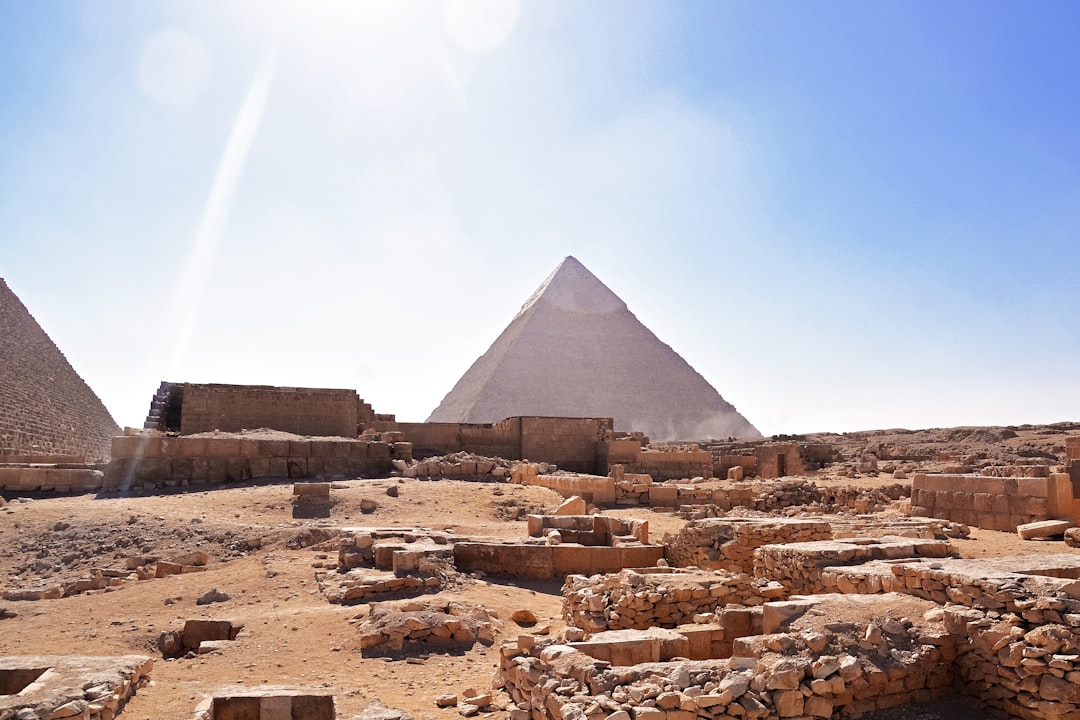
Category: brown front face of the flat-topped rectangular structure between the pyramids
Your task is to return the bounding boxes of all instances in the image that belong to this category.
[180,383,362,438]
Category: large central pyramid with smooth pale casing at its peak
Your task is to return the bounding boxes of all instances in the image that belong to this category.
[428,257,761,440]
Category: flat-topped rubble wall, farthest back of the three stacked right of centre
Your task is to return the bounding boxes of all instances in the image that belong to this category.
[666,518,833,574]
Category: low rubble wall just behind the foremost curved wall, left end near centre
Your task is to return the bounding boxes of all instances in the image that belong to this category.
[563,568,783,634]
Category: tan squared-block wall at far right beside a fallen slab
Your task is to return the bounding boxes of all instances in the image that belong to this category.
[912,473,1074,531]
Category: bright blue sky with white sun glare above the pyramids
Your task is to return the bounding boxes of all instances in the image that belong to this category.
[0,0,1080,434]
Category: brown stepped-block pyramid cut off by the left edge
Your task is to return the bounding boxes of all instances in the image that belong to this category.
[0,279,120,460]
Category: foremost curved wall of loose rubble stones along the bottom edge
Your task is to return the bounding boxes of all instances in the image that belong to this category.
[499,604,953,720]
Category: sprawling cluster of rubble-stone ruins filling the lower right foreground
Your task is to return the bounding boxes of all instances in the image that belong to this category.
[498,526,1080,720]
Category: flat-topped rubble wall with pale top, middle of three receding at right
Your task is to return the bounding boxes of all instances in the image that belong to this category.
[754,536,953,595]
